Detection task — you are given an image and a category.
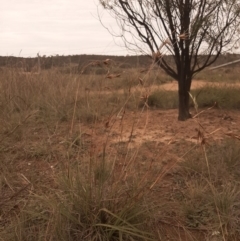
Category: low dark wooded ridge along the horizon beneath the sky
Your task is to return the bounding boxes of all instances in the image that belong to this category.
[0,54,240,72]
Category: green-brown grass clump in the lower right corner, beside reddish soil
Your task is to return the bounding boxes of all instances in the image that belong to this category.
[175,140,240,240]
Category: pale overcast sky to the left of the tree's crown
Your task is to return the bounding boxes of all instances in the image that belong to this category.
[0,0,131,57]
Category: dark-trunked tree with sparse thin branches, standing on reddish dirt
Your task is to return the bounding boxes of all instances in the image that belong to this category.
[99,0,240,121]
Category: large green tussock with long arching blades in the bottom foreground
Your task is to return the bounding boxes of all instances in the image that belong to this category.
[6,155,154,241]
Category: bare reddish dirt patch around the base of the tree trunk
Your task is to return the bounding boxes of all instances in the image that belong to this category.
[83,109,240,153]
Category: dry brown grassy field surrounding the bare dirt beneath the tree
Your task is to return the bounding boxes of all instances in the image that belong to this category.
[0,58,240,241]
